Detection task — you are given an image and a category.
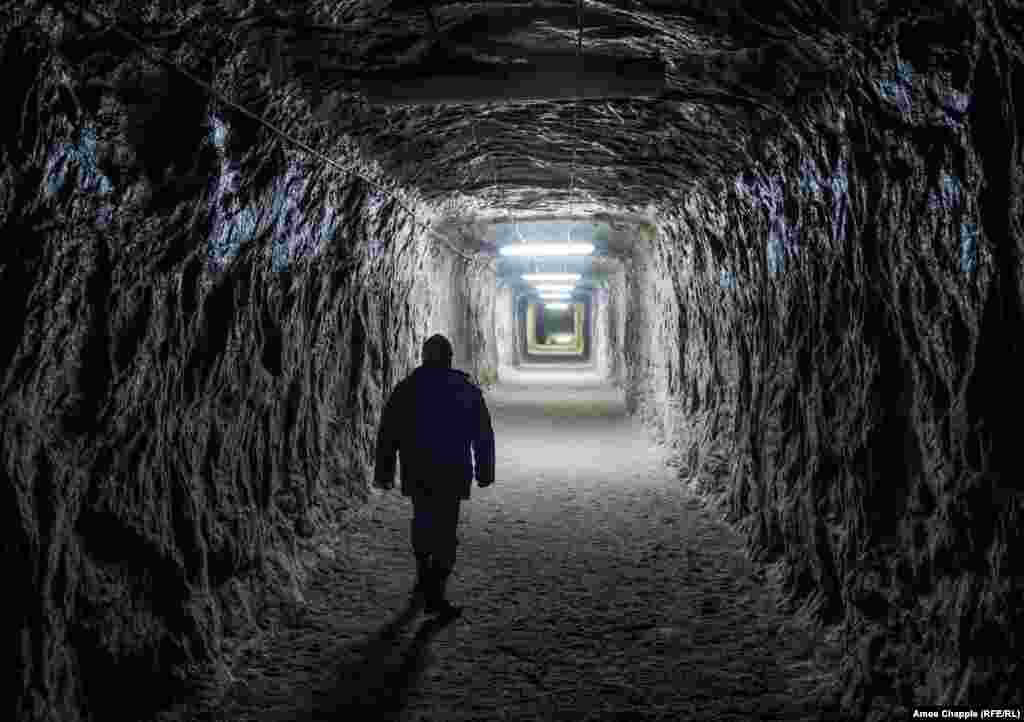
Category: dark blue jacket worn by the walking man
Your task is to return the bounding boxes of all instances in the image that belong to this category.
[374,366,495,499]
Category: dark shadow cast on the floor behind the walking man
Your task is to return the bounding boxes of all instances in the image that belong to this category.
[309,604,452,722]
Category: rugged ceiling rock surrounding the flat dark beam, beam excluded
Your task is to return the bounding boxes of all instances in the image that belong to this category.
[309,2,856,215]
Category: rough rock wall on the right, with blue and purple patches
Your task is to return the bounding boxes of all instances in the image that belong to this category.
[628,3,1024,720]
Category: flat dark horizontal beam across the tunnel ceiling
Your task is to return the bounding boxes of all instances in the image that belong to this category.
[358,54,665,105]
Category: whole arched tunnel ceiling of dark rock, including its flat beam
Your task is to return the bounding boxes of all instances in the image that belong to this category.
[230,0,856,218]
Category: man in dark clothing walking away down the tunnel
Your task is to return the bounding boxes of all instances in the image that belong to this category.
[374,334,495,619]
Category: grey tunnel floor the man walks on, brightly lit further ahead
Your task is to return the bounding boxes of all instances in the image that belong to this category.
[151,365,842,722]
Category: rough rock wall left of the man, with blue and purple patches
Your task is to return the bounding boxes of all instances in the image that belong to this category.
[0,13,487,722]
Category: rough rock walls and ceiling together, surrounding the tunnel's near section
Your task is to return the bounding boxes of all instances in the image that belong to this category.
[8,0,1024,720]
